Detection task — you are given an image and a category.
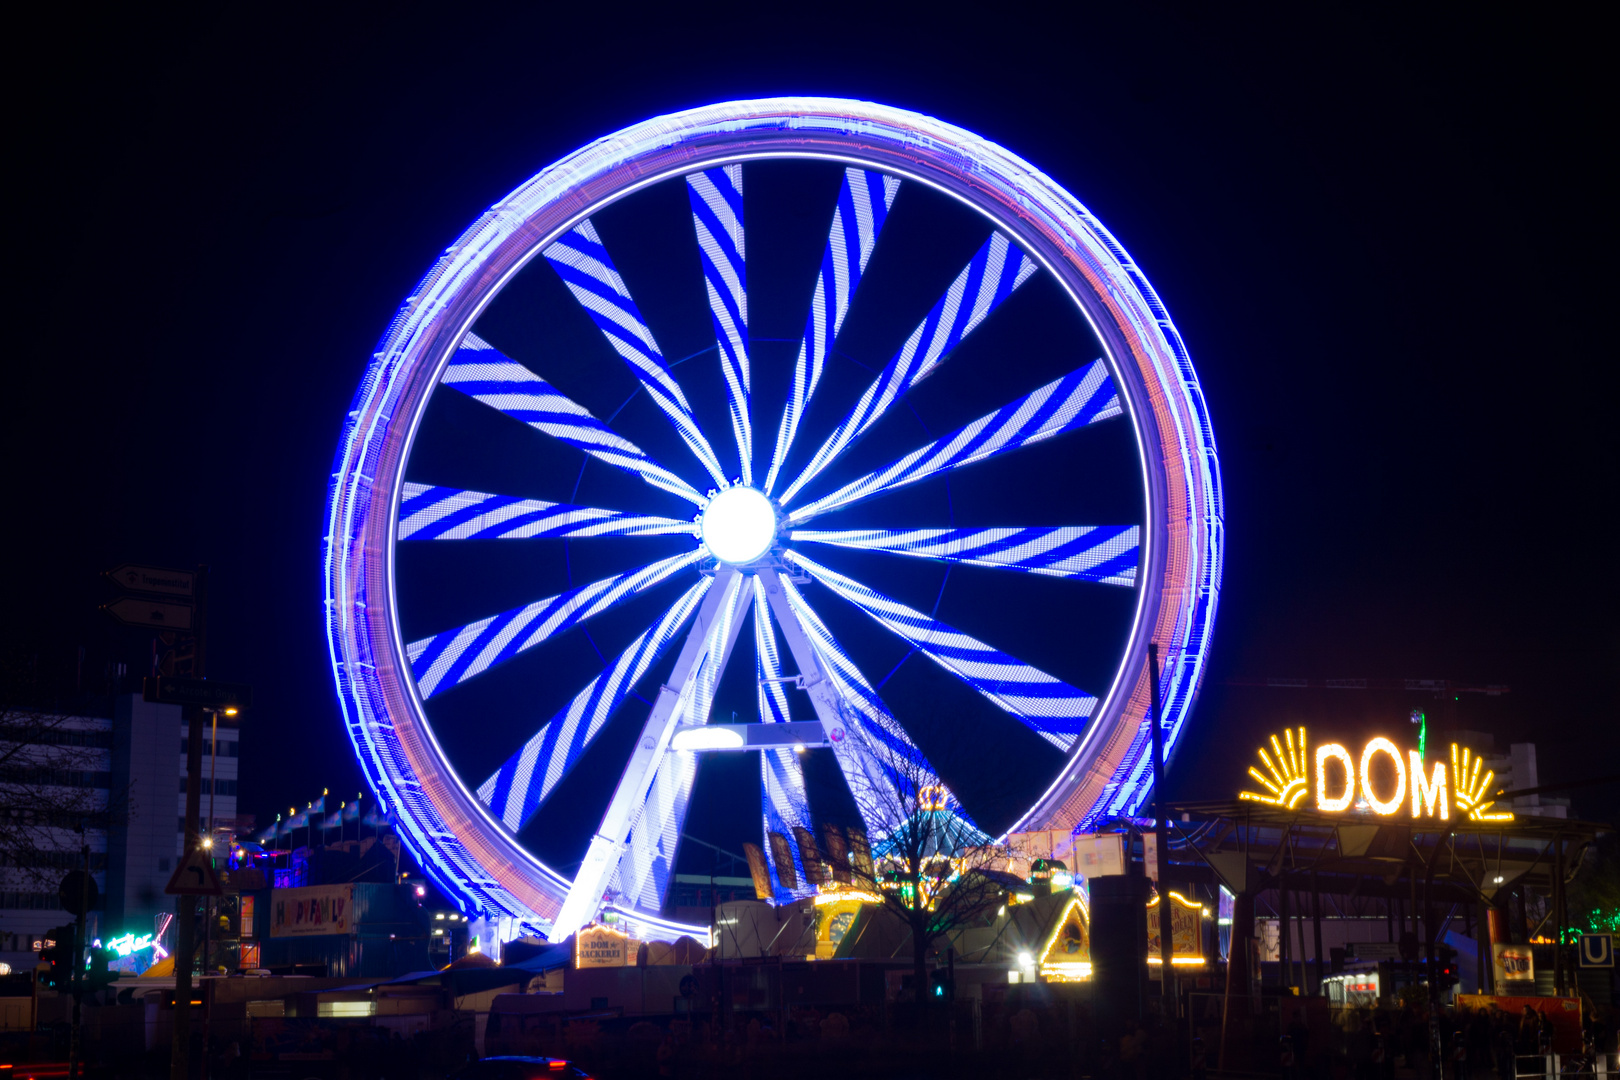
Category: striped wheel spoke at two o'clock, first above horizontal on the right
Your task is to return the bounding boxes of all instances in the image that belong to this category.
[787,359,1123,525]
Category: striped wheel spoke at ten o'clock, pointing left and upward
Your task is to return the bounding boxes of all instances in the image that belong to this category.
[442,334,708,507]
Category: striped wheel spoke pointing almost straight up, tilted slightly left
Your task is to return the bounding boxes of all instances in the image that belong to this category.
[687,165,753,484]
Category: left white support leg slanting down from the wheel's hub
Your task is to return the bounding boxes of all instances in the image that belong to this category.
[551,568,753,941]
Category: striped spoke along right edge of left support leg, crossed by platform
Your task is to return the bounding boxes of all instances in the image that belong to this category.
[608,573,753,912]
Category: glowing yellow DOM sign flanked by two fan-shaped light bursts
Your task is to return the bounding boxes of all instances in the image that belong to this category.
[1238,727,1513,821]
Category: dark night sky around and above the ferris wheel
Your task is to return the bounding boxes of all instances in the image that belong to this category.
[0,5,1620,867]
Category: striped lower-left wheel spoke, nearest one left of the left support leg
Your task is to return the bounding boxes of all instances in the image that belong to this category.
[478,578,714,832]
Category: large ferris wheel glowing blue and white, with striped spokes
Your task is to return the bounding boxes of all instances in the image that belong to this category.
[326,99,1221,939]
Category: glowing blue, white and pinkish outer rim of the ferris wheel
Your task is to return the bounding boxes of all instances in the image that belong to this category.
[324,97,1223,929]
